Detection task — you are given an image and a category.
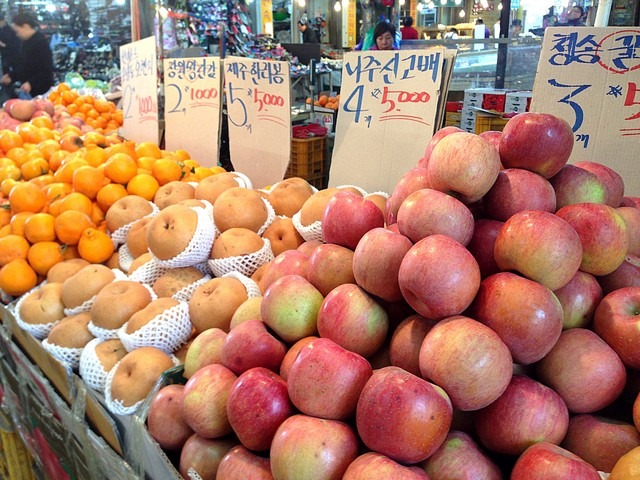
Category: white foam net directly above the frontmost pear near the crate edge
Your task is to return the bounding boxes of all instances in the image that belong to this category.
[118,302,193,354]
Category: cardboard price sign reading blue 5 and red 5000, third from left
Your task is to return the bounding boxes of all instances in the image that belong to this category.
[224,57,291,188]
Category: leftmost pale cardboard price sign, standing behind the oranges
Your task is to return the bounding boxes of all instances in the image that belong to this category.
[120,37,159,144]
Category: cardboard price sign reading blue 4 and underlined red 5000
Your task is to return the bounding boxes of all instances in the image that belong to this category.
[329,48,444,193]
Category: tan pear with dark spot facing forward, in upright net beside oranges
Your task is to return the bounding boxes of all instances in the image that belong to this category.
[147,205,198,260]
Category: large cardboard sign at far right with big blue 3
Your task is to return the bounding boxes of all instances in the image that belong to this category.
[531,27,640,195]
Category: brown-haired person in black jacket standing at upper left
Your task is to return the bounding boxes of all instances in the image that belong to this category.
[2,13,53,97]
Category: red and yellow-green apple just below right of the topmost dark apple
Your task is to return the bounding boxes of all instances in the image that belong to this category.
[549,165,607,209]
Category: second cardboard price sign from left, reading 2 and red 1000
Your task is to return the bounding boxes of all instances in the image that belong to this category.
[164,57,222,167]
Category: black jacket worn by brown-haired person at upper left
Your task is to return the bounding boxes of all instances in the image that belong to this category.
[9,30,53,97]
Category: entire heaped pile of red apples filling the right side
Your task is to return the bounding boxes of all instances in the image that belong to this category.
[147,113,640,480]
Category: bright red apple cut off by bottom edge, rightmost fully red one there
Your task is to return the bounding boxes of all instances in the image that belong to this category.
[511,442,600,480]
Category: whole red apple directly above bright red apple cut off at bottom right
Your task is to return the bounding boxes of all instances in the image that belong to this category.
[475,374,569,455]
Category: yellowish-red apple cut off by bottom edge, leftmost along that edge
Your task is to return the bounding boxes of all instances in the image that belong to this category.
[180,434,238,480]
